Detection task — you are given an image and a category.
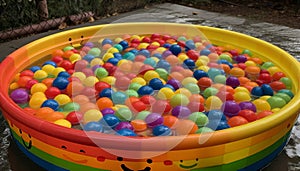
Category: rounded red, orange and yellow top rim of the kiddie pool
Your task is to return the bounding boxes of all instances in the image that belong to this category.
[0,23,300,150]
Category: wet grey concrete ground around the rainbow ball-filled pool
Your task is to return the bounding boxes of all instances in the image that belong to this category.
[0,3,300,171]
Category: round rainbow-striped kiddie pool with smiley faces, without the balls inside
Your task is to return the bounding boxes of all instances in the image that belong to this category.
[0,23,300,171]
